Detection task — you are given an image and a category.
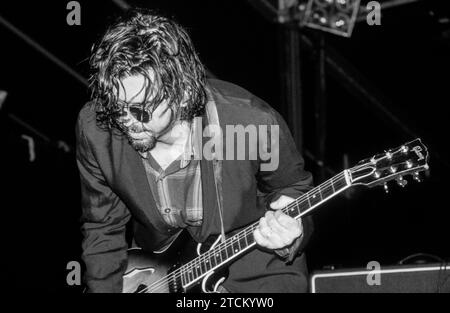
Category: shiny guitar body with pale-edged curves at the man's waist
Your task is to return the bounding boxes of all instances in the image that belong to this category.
[122,231,228,293]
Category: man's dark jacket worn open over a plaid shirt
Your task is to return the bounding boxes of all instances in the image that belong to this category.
[76,80,312,292]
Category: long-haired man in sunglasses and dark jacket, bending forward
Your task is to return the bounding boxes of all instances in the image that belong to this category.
[76,10,312,292]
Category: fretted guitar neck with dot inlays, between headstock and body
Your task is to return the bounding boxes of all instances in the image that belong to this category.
[180,170,352,287]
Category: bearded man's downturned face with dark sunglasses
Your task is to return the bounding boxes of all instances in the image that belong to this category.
[118,74,173,152]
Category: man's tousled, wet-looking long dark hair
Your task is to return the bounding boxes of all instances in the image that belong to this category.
[90,9,206,129]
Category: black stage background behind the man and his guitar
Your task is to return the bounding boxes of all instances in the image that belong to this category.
[0,0,450,292]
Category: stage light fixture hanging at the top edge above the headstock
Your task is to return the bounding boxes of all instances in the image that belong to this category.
[300,0,360,37]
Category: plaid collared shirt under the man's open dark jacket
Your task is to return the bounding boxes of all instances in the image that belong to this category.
[142,119,203,228]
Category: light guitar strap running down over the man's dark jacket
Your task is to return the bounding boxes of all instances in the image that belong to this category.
[206,90,225,242]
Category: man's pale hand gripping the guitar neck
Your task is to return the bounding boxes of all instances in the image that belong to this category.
[253,195,303,250]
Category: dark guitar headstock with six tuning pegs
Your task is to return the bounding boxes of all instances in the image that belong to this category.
[349,139,429,191]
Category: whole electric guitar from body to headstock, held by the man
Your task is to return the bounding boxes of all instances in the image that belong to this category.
[123,139,429,293]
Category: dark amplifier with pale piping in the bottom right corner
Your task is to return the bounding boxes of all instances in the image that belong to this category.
[310,263,450,293]
